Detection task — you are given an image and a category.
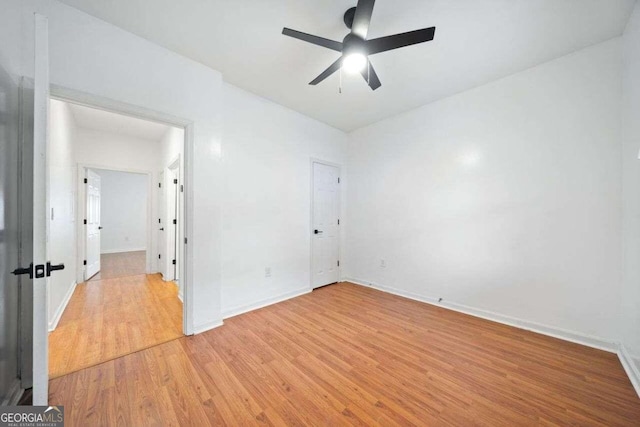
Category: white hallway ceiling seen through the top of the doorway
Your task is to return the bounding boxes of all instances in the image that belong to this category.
[69,104,170,142]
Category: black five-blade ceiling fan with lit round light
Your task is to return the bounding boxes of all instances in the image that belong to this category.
[282,0,436,90]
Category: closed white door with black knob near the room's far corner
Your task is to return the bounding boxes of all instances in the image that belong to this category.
[311,163,340,288]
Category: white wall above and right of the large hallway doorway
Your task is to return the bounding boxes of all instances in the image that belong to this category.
[14,0,222,331]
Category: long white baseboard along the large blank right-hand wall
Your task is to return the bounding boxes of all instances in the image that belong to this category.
[344,278,618,353]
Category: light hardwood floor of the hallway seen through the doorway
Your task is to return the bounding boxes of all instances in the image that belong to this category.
[49,274,183,378]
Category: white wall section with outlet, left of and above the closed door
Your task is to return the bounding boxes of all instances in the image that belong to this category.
[222,84,347,317]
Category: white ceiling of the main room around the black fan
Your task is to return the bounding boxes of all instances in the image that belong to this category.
[56,0,635,131]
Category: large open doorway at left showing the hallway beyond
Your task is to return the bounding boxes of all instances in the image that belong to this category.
[49,98,188,378]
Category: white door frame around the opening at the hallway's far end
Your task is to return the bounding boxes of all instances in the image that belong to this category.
[75,163,154,283]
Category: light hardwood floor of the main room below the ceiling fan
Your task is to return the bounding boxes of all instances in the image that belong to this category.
[50,283,640,426]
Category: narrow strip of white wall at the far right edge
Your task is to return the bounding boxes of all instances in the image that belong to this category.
[620,3,640,374]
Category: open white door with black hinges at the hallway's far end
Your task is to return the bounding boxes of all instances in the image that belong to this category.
[85,169,102,279]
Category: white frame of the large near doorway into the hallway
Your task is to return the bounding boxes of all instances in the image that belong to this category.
[50,84,195,335]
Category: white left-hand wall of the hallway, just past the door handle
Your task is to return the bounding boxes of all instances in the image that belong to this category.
[47,100,77,329]
